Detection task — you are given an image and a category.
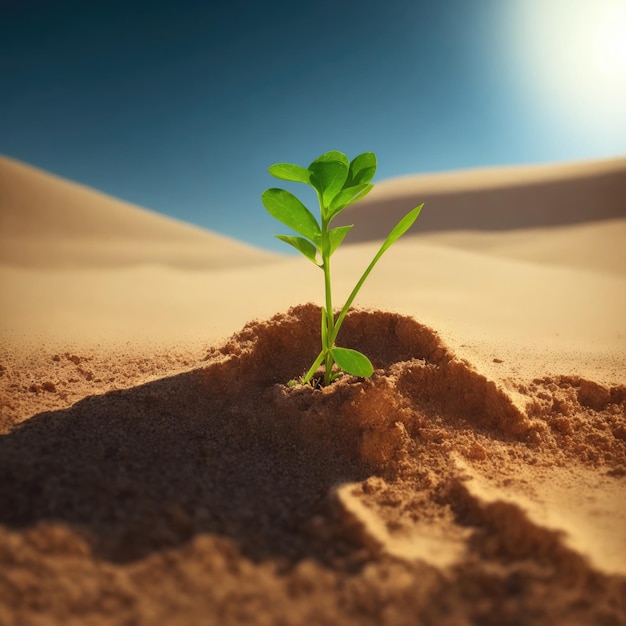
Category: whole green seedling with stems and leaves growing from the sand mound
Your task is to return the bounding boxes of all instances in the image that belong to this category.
[262,150,423,385]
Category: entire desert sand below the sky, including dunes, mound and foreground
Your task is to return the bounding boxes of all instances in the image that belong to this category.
[0,152,626,626]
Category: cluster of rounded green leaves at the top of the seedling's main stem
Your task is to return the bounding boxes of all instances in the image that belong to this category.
[262,150,376,265]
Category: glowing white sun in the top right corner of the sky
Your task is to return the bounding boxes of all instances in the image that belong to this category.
[515,0,626,138]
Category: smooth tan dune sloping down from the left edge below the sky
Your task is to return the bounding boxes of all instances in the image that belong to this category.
[0,157,276,269]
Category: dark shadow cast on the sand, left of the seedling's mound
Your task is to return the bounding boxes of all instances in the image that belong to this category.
[0,358,364,561]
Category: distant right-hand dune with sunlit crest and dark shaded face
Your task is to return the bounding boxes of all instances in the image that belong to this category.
[338,159,626,242]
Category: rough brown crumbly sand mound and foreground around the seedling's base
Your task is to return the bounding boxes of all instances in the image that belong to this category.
[0,305,626,626]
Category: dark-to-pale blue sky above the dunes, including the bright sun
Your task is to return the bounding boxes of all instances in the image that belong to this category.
[0,0,626,252]
